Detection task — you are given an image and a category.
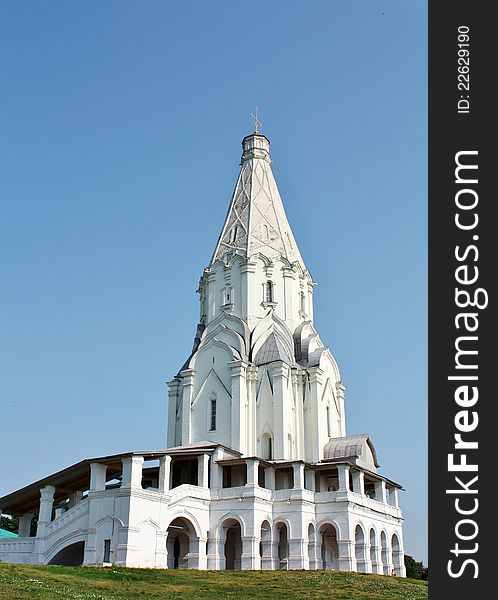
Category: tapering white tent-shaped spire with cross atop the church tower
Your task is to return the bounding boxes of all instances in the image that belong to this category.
[210,132,306,270]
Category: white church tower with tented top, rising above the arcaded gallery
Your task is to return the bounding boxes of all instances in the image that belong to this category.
[168,131,346,462]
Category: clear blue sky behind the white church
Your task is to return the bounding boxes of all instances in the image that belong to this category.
[0,0,427,562]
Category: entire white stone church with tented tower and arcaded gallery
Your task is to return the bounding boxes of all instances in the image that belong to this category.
[0,130,405,576]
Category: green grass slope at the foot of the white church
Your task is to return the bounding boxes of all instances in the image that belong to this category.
[0,563,427,600]
